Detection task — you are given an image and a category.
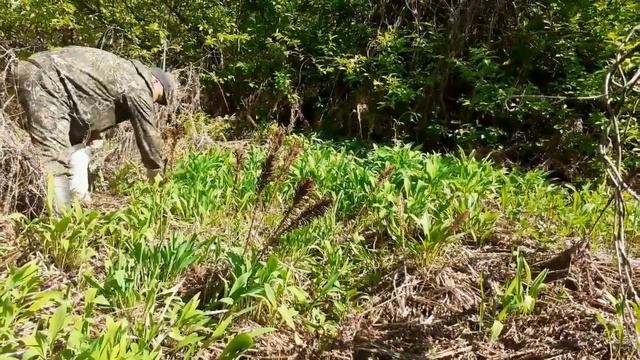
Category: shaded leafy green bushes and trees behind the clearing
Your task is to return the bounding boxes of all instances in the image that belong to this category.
[0,0,640,180]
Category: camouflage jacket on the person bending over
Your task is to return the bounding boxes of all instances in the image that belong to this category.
[27,46,162,169]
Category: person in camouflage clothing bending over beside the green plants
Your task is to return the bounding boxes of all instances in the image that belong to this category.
[15,46,173,213]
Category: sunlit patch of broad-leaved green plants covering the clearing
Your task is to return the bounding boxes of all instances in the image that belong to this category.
[0,122,640,359]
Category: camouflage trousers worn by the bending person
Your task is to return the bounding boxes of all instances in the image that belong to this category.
[15,61,89,208]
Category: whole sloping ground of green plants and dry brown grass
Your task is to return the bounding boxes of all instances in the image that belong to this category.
[0,121,640,359]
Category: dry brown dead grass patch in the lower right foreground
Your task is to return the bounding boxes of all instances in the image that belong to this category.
[241,236,640,359]
